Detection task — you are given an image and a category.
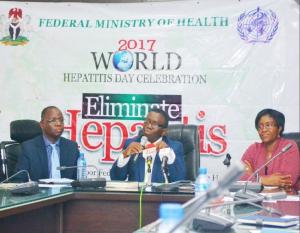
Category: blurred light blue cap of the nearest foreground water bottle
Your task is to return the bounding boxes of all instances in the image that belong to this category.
[159,203,184,220]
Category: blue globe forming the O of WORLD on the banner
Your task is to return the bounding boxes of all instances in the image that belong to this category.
[113,50,133,72]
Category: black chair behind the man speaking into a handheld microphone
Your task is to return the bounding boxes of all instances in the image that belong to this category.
[167,124,200,181]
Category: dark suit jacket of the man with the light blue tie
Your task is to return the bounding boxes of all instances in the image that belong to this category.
[16,135,79,181]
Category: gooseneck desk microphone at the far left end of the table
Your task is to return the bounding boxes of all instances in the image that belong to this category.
[0,170,39,195]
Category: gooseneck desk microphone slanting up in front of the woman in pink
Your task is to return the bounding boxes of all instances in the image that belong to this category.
[235,143,293,201]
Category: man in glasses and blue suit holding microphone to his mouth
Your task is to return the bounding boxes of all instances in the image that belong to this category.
[110,109,185,183]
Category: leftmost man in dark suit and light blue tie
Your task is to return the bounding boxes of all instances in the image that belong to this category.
[16,106,79,181]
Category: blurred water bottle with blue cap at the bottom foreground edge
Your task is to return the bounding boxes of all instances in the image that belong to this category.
[157,203,185,233]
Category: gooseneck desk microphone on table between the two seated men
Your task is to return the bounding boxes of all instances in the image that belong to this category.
[56,165,106,188]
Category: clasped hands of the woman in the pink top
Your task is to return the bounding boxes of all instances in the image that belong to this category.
[261,173,292,189]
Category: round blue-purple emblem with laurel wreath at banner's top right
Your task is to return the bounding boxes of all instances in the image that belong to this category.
[237,7,279,43]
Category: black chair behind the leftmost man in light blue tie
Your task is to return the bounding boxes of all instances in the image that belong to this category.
[0,120,42,179]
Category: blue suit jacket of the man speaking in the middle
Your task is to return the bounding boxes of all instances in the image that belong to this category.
[110,137,185,183]
